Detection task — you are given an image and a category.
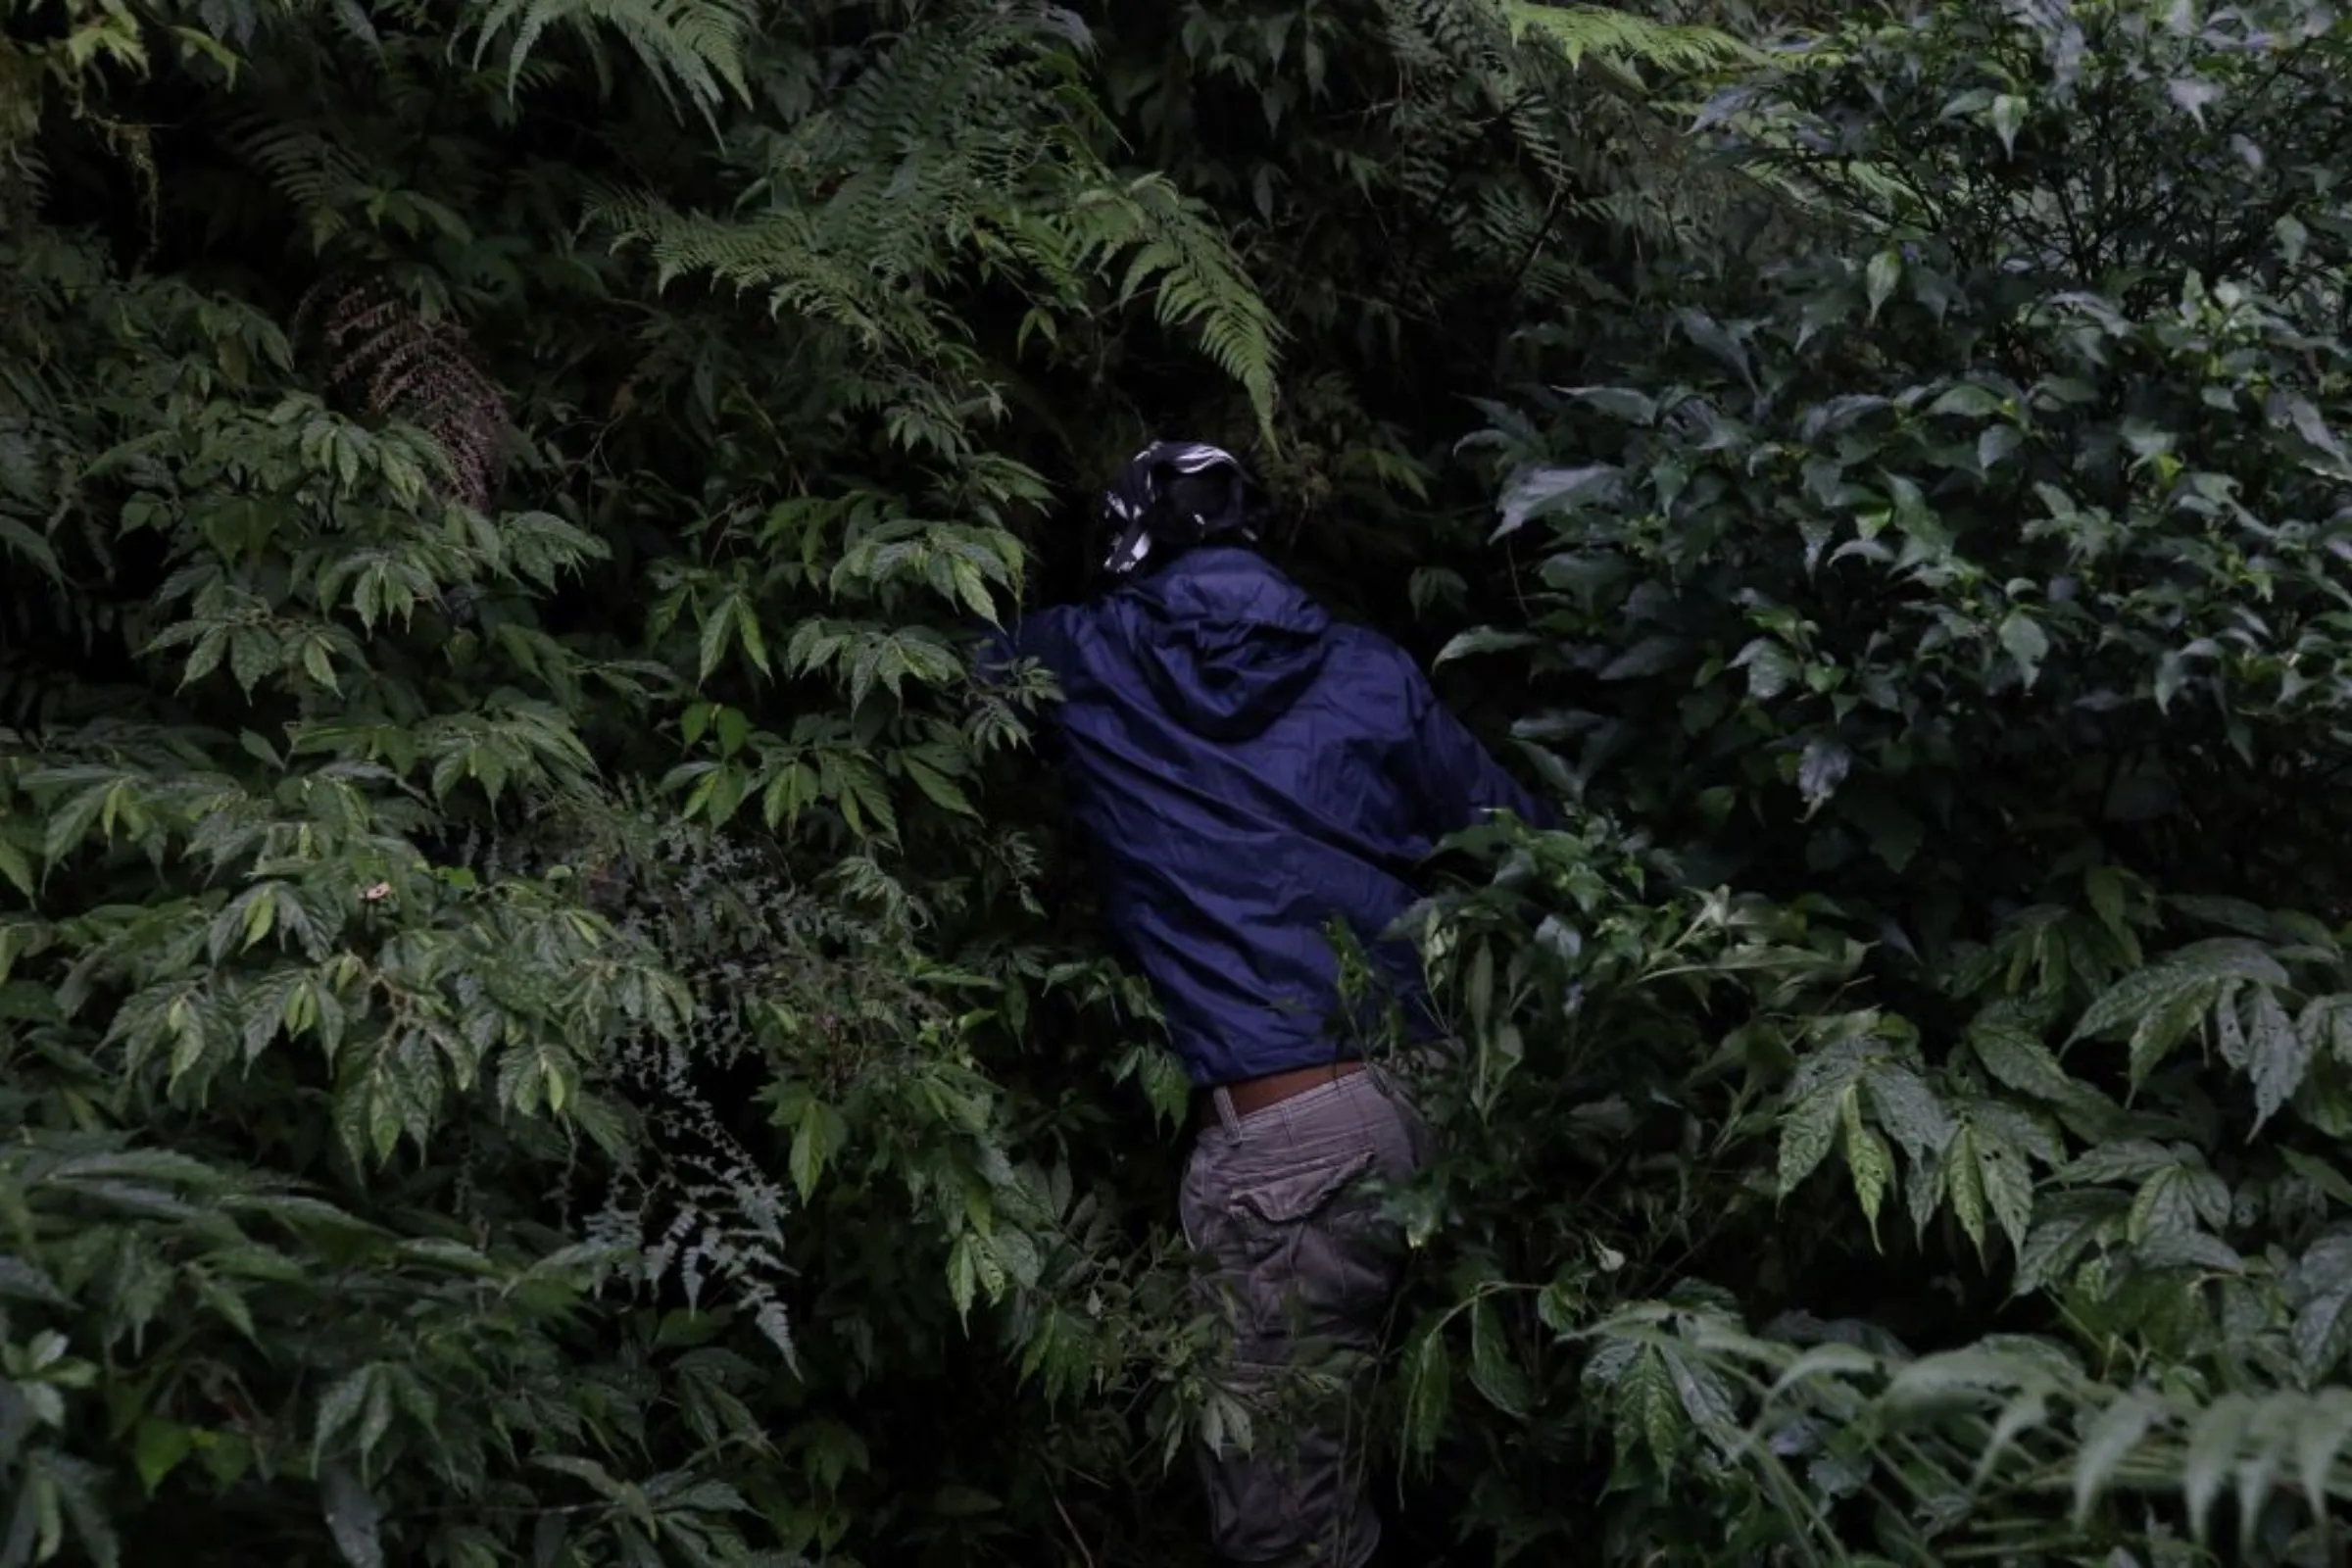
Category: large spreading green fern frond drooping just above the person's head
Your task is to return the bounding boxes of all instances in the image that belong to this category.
[590,5,1280,441]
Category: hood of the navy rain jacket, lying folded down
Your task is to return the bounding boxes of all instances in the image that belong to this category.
[1119,546,1331,741]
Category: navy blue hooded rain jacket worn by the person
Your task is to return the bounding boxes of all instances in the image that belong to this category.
[998,546,1557,1084]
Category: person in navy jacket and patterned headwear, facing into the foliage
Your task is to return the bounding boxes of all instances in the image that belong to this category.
[998,442,1552,1568]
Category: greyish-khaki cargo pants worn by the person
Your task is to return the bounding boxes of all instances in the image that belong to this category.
[1178,1067,1428,1568]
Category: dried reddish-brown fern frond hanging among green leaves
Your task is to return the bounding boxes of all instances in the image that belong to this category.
[294,277,508,508]
